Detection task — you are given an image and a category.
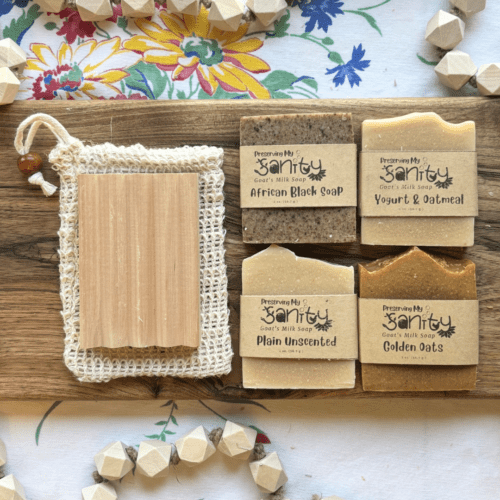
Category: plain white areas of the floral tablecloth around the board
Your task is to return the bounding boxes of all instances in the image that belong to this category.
[0,0,500,500]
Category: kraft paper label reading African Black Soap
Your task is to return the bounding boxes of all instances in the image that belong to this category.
[240,144,357,208]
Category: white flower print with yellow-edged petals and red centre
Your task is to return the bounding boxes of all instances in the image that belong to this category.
[24,37,142,100]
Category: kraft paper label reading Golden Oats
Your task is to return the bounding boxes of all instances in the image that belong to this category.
[359,299,479,365]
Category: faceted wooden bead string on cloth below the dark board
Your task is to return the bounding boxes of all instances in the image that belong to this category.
[0,421,341,500]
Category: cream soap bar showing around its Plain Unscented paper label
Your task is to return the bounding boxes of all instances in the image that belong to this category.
[242,245,356,389]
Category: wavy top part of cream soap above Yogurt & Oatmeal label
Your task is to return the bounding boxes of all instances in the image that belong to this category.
[361,112,476,151]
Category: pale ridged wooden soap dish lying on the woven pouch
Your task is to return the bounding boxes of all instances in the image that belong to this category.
[78,173,200,349]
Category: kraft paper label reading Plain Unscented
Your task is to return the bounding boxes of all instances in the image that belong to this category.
[240,295,358,359]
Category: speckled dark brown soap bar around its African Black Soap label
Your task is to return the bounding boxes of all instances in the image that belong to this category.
[240,113,356,243]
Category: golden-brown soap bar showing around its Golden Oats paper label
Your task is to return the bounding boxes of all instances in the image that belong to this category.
[359,247,477,391]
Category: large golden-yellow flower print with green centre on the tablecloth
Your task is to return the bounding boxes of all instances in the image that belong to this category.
[124,7,271,99]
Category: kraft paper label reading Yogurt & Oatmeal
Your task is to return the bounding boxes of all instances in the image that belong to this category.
[360,151,478,217]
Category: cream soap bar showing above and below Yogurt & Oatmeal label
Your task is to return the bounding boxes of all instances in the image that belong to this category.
[361,113,476,247]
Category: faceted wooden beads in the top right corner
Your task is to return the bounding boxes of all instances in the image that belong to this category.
[425,0,500,96]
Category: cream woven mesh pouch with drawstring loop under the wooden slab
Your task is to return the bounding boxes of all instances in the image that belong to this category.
[15,114,233,382]
